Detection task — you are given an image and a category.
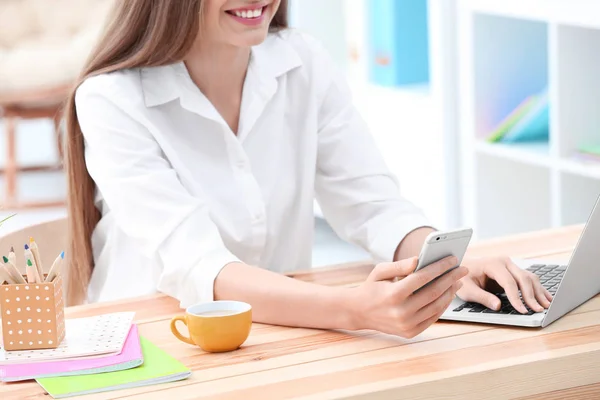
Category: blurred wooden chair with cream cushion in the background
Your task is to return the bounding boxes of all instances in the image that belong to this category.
[0,0,117,209]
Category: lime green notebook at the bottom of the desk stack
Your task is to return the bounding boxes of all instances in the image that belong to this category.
[37,337,191,399]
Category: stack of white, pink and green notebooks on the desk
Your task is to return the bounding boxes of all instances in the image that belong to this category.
[0,313,191,399]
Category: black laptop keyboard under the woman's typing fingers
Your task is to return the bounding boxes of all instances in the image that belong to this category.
[452,264,567,315]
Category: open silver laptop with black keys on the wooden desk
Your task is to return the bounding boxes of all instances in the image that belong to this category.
[440,194,600,327]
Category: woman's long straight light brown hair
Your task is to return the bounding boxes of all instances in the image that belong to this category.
[64,0,288,305]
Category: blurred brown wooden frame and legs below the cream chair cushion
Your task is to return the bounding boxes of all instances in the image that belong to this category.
[0,85,69,209]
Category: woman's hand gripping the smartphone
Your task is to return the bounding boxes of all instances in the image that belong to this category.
[354,257,468,338]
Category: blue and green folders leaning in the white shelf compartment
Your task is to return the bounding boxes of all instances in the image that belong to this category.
[487,91,550,143]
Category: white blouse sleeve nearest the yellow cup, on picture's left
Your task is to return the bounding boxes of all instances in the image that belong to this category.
[76,78,239,307]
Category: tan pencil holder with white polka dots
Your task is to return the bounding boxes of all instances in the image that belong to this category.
[0,275,65,351]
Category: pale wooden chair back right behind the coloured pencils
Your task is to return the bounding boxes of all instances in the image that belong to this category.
[0,215,68,273]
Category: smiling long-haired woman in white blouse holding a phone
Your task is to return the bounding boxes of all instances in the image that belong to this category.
[67,0,551,337]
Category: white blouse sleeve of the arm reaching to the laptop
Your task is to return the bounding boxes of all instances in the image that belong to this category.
[314,39,430,261]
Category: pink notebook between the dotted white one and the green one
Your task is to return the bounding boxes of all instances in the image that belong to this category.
[0,325,144,382]
